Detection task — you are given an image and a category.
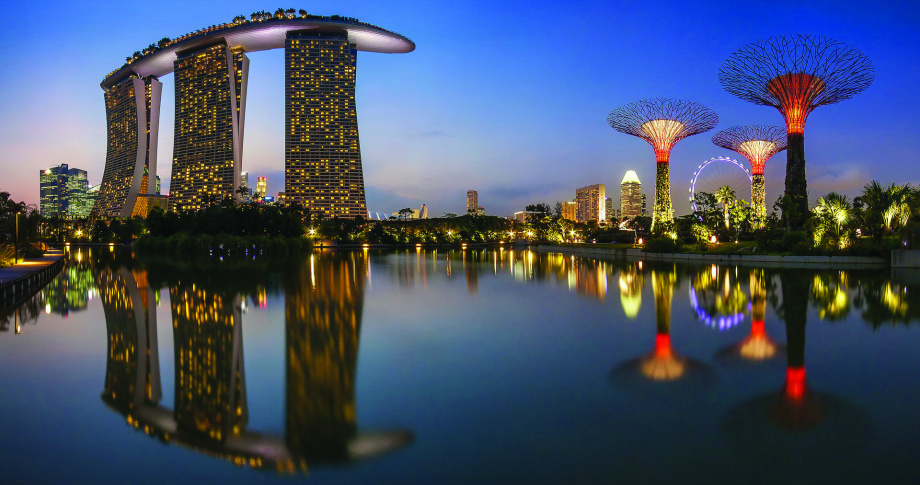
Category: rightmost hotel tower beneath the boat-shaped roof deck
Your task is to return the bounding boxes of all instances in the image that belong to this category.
[284,30,367,219]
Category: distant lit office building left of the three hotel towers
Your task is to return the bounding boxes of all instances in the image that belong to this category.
[39,163,93,219]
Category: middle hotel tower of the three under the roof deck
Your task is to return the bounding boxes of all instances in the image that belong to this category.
[169,41,249,210]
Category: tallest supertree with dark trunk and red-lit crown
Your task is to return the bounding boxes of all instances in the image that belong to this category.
[719,35,875,229]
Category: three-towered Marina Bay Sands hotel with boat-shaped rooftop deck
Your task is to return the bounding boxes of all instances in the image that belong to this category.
[92,9,415,218]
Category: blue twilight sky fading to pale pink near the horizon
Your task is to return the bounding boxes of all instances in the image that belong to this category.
[0,0,920,215]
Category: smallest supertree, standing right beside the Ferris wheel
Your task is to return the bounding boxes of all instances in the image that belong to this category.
[712,125,787,229]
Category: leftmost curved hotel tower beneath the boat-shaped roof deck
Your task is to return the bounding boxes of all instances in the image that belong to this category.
[92,76,163,218]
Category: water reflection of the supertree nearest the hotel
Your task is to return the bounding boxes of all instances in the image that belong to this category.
[610,266,715,391]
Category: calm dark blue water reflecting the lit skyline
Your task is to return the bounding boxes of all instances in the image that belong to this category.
[0,248,920,484]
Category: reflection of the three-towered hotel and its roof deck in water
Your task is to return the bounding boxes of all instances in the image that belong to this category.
[97,253,413,473]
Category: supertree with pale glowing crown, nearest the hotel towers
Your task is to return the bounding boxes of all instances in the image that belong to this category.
[607,98,719,230]
